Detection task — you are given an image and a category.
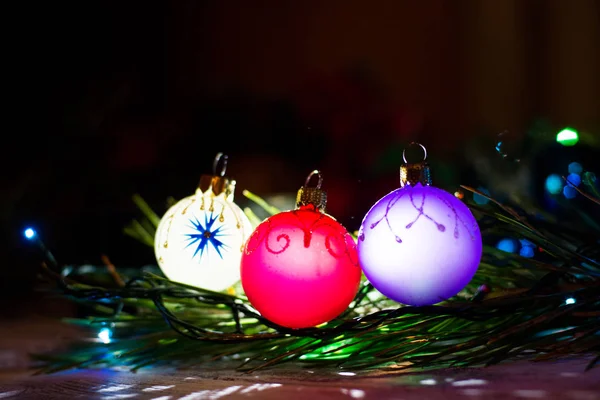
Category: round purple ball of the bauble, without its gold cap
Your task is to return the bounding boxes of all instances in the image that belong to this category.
[358,183,482,306]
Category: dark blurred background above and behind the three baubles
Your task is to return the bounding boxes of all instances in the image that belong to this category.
[0,0,600,298]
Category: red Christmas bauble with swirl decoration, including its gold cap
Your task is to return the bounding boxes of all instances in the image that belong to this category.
[241,171,361,328]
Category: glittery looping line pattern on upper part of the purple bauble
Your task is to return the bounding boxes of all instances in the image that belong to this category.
[366,187,475,243]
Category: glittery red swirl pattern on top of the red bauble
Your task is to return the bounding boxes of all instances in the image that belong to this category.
[246,205,358,265]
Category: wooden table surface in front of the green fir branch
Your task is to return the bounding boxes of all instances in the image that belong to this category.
[0,317,600,400]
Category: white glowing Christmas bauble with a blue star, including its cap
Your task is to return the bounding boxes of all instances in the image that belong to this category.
[154,155,252,291]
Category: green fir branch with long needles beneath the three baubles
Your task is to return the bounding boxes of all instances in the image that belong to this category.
[39,186,600,373]
